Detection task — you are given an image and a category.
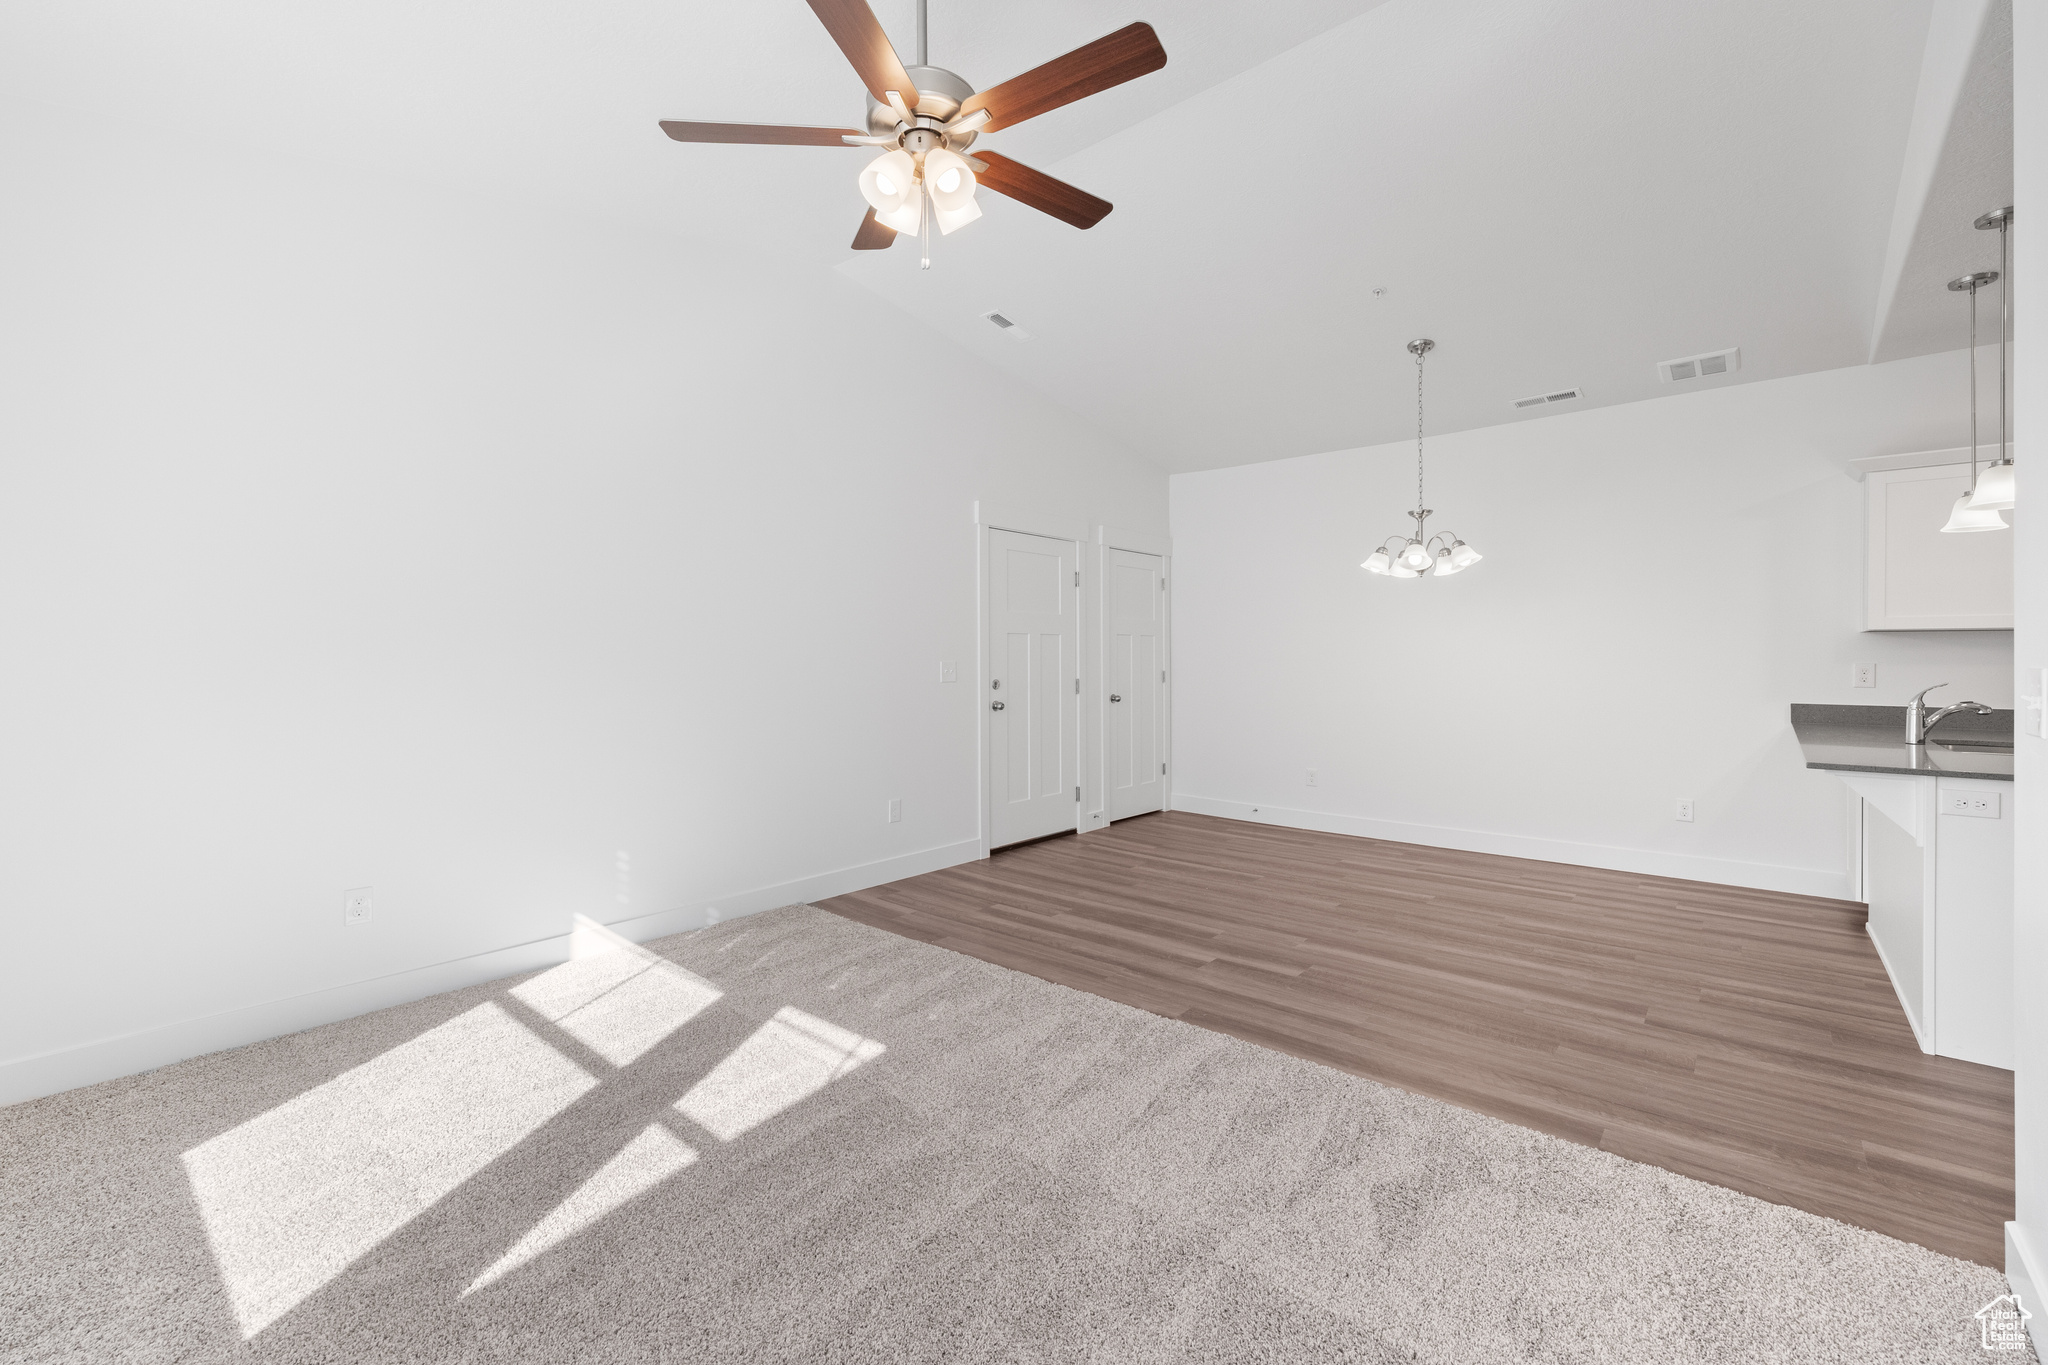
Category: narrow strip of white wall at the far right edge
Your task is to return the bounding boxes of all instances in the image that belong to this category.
[2005,0,2048,1359]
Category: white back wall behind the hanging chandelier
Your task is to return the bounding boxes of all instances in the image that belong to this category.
[1171,351,2013,894]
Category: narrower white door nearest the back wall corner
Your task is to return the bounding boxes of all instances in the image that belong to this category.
[1106,551,1165,821]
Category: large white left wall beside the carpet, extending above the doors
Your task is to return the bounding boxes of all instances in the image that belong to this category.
[0,93,1165,1099]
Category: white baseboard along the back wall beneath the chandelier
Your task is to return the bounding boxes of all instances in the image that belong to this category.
[1174,792,1849,900]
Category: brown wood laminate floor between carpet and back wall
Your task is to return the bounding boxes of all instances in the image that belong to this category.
[819,812,2013,1267]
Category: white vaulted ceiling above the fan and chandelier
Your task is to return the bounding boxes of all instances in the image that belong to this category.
[0,0,2011,469]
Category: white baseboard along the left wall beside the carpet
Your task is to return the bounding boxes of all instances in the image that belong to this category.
[0,839,981,1105]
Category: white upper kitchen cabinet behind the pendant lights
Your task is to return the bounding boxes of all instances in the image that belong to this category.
[1864,456,2013,630]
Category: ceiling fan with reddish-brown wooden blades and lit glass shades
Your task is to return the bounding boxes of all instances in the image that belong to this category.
[662,0,1165,268]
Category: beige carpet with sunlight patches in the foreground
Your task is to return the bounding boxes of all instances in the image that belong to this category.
[0,907,2023,1365]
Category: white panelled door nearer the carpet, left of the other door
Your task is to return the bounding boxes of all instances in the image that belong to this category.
[983,530,1081,847]
